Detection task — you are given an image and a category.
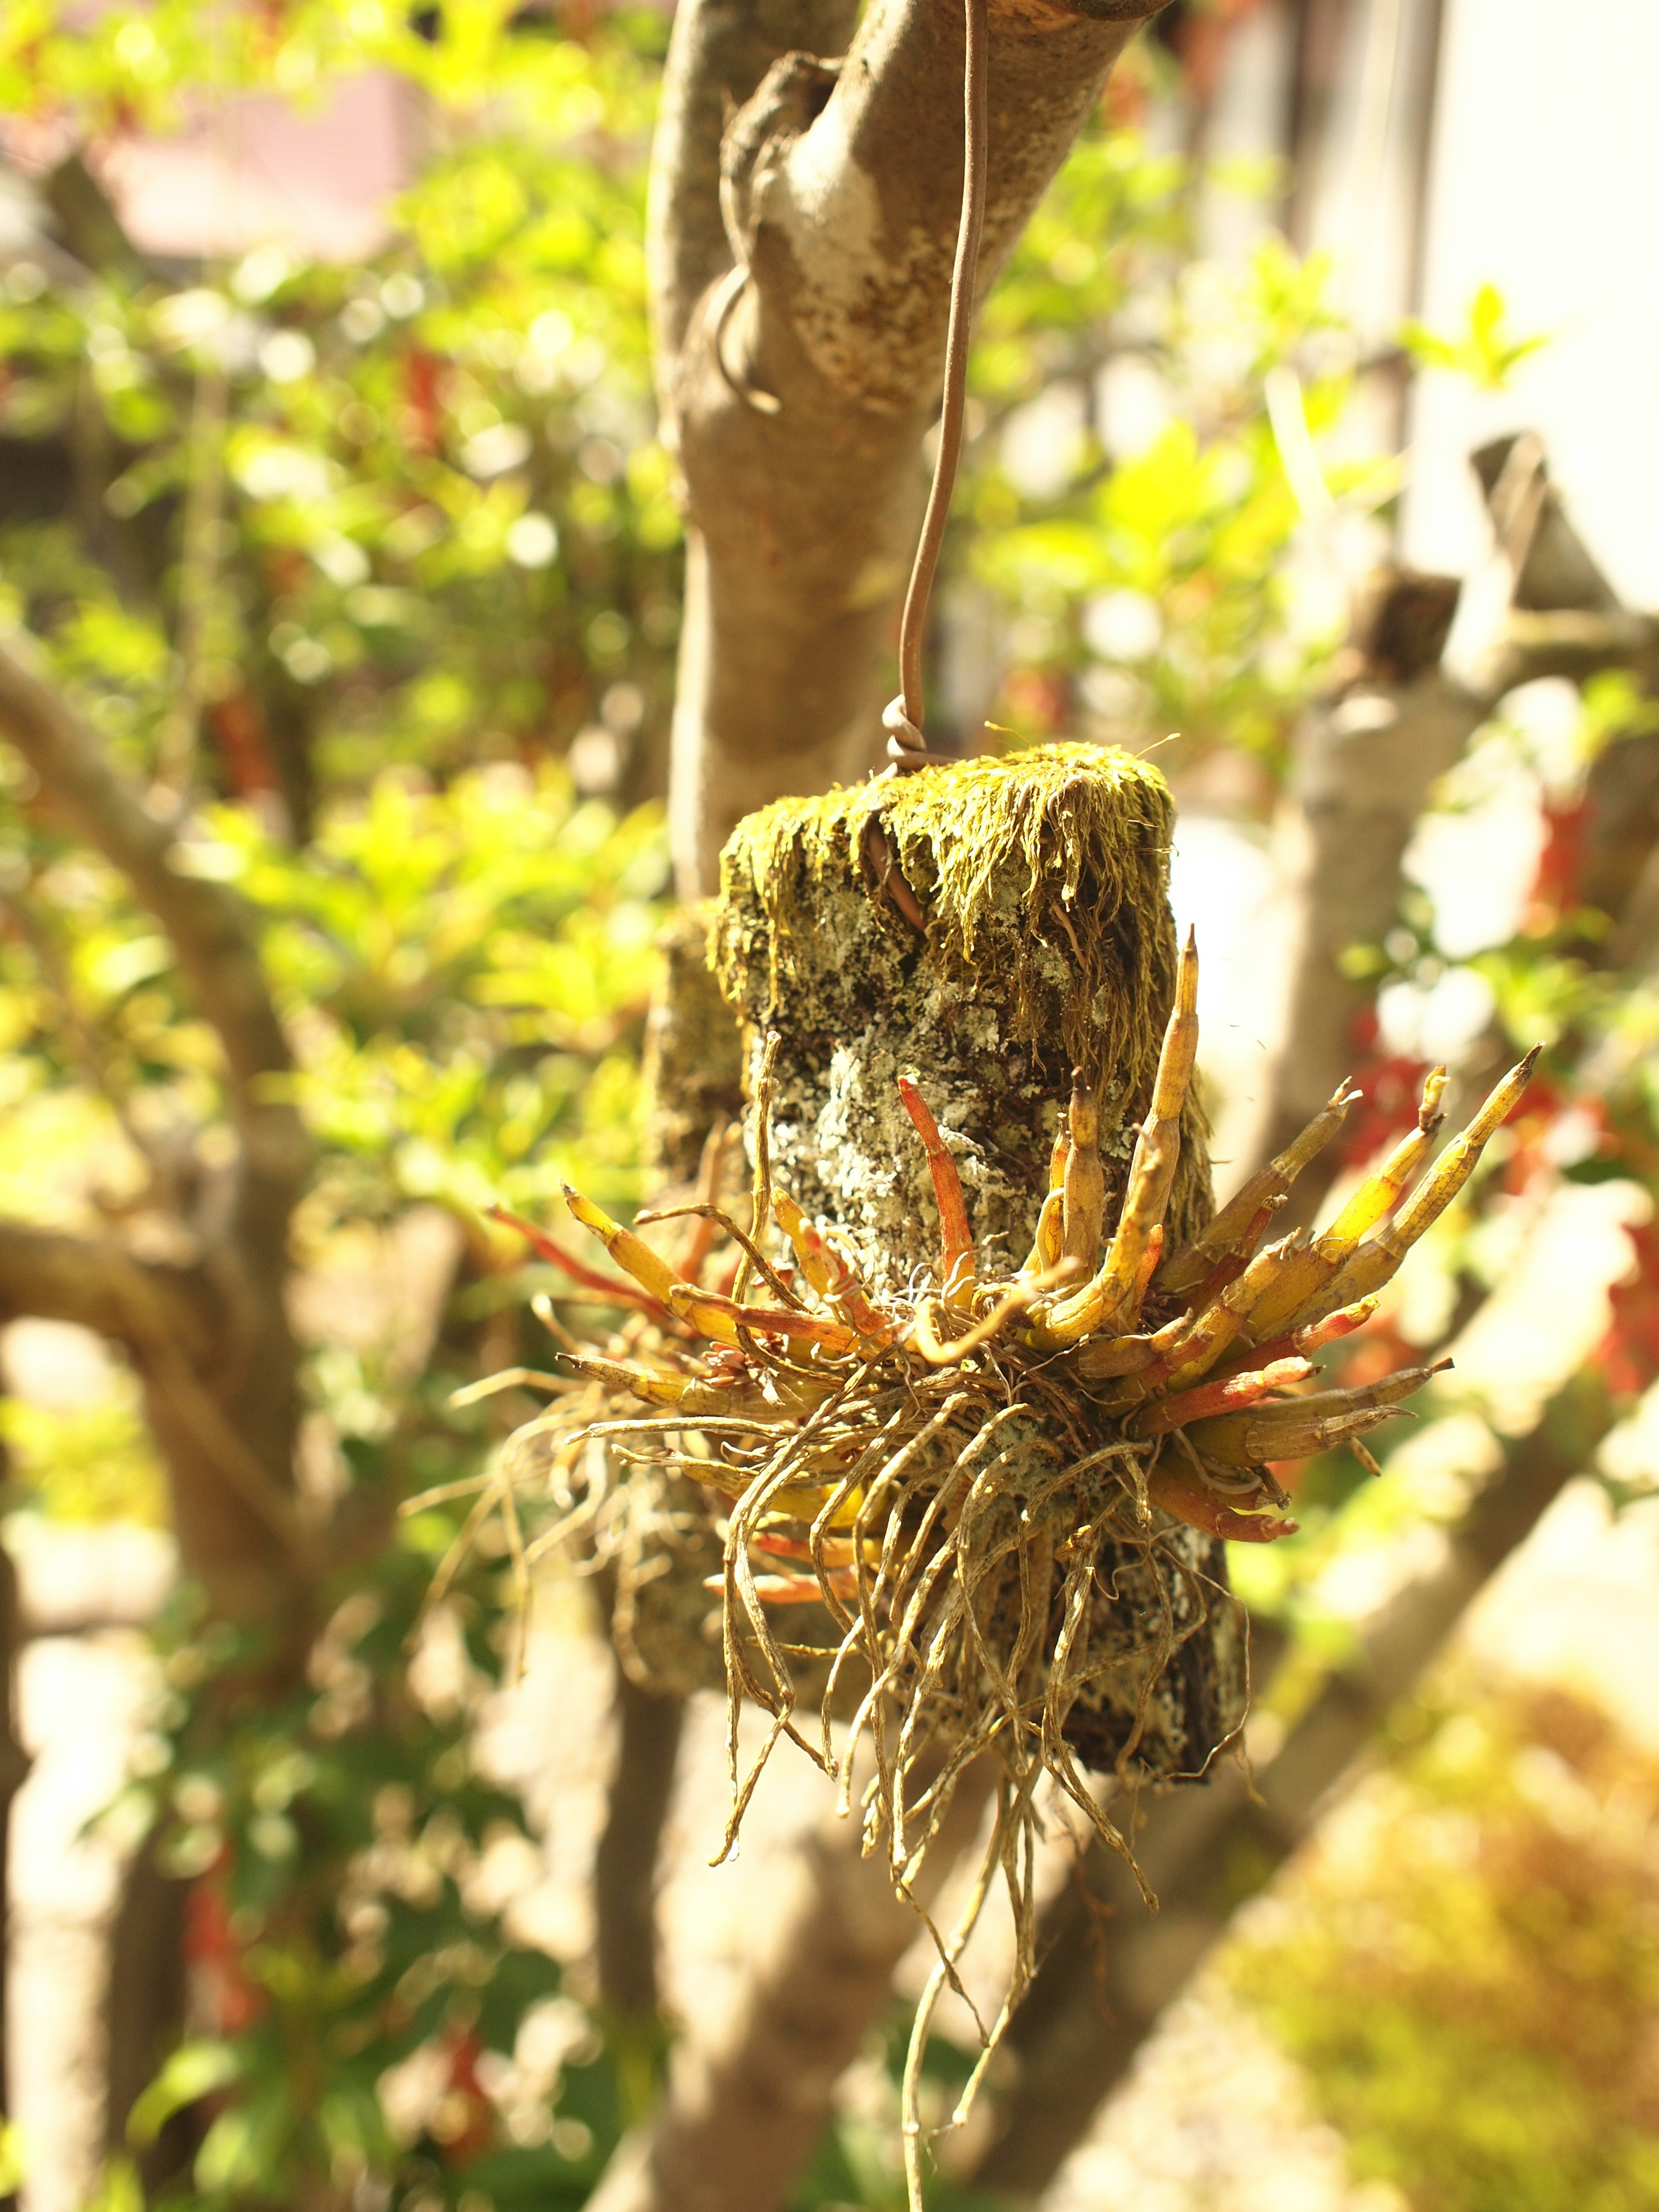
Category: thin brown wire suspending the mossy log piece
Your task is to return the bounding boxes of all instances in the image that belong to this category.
[880,0,989,770]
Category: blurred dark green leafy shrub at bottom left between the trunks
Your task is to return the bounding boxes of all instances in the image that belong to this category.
[106,1513,620,2212]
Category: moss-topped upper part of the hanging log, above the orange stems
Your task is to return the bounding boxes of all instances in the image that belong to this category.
[717,745,1210,1292]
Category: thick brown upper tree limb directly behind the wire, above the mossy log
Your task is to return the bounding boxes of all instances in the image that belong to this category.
[652,0,1157,896]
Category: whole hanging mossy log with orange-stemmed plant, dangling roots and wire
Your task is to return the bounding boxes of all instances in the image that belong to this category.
[422,0,1531,2206]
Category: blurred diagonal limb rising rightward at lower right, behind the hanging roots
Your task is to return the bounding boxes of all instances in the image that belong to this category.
[973,1385,1610,2203]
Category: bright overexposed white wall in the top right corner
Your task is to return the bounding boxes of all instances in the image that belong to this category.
[1405,0,1659,608]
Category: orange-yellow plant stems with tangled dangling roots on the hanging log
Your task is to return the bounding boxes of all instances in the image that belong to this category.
[422,942,1535,2192]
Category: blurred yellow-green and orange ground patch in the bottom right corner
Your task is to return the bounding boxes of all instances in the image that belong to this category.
[1228,1681,1659,2212]
